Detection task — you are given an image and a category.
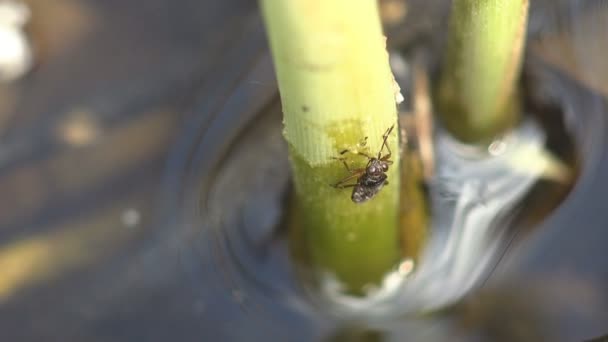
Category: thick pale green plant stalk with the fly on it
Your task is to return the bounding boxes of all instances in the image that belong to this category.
[260,0,400,294]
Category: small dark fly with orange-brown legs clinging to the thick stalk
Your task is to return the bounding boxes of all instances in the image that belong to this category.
[332,125,395,203]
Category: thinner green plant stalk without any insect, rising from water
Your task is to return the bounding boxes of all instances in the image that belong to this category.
[437,0,528,143]
